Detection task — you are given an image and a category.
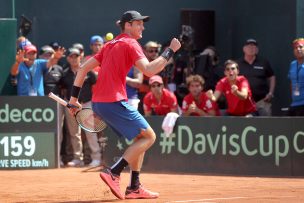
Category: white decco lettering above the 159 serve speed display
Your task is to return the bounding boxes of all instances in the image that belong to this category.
[0,104,55,123]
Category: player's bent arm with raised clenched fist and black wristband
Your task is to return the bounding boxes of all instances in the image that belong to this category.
[135,38,181,77]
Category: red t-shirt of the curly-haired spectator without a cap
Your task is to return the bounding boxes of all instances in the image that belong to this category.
[182,92,220,116]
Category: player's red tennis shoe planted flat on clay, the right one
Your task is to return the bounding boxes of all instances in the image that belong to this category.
[125,185,159,199]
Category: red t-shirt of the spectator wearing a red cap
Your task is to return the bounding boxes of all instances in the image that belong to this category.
[144,88,177,115]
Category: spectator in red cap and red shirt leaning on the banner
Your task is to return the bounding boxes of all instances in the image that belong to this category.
[144,75,177,116]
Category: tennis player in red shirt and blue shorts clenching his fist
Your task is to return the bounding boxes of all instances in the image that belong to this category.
[69,11,181,199]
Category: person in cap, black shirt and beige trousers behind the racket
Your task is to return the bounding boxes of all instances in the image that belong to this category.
[60,47,101,167]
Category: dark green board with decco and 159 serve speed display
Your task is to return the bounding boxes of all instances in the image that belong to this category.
[0,96,57,169]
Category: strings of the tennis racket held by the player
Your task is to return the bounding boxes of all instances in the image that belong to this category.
[75,109,107,132]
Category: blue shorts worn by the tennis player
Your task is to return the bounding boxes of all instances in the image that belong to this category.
[92,101,150,140]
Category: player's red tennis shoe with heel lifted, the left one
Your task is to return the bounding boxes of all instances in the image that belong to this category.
[100,169,125,199]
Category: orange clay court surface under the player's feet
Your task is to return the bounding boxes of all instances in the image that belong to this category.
[0,168,304,203]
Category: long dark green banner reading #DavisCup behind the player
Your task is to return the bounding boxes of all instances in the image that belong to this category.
[105,116,304,176]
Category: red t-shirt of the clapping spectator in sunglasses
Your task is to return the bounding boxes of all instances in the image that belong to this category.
[215,76,256,116]
